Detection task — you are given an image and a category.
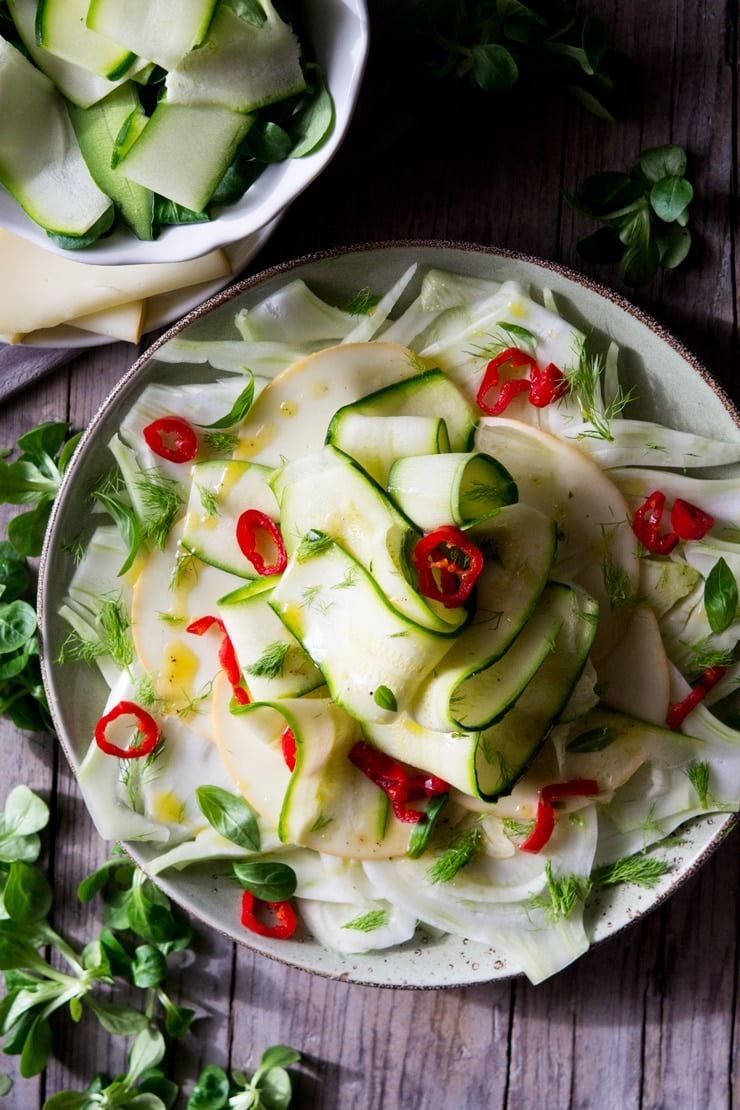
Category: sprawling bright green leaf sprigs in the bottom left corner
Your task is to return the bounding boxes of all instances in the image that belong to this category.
[0,785,300,1110]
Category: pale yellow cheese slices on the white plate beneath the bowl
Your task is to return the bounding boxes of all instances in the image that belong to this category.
[0,229,231,343]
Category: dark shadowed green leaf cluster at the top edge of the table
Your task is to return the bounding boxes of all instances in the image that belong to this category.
[406,0,622,120]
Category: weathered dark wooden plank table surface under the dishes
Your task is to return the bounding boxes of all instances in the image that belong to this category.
[0,0,740,1110]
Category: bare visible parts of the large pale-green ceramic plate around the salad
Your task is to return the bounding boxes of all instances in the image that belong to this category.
[41,243,740,987]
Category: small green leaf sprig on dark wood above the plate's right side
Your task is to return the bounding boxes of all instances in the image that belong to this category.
[565,143,693,286]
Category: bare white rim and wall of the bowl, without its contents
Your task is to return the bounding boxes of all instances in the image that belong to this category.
[0,0,368,265]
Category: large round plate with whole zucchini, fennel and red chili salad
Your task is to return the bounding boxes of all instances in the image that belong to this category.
[40,242,740,987]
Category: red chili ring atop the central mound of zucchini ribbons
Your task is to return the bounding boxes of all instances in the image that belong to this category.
[412,524,483,609]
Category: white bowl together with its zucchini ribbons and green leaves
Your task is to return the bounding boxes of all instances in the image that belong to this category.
[0,0,368,265]
